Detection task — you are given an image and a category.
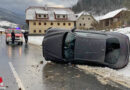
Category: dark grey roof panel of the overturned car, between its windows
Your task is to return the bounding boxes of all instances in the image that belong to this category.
[74,33,106,62]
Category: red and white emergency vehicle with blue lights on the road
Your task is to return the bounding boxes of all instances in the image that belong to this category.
[5,28,23,45]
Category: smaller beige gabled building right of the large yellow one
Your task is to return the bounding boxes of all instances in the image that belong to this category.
[76,11,97,30]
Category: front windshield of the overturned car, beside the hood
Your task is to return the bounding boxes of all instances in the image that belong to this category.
[64,33,75,59]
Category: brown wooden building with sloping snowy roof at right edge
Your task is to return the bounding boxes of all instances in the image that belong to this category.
[99,8,130,30]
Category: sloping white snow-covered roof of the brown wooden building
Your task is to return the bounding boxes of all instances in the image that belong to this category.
[100,8,127,20]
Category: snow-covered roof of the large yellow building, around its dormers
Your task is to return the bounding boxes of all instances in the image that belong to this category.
[26,7,76,21]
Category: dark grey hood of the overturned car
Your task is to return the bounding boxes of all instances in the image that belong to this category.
[43,32,65,60]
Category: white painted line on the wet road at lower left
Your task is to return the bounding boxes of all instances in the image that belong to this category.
[9,62,25,90]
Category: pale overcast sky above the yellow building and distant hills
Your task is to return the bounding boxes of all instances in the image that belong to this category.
[0,0,78,13]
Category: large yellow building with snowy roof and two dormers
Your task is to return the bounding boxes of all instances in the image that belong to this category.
[26,6,76,35]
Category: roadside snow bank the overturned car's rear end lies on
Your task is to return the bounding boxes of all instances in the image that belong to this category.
[78,27,130,88]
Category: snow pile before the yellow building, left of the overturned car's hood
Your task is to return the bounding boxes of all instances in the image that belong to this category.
[29,36,44,46]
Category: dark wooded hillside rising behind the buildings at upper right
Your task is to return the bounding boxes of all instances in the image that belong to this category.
[72,0,125,15]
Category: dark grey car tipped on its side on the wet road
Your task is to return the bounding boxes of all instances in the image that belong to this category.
[42,29,129,69]
